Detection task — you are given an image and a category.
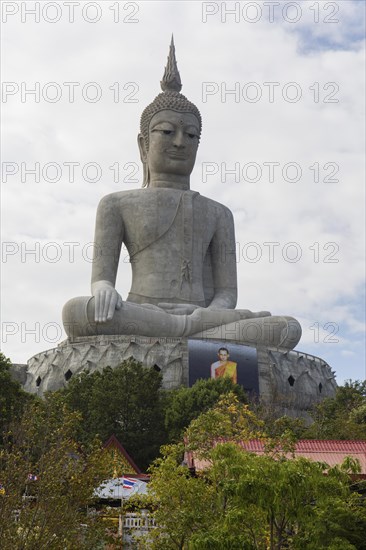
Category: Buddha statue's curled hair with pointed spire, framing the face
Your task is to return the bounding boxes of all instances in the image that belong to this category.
[140,36,202,187]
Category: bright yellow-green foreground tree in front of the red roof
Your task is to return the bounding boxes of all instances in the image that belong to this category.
[141,394,366,550]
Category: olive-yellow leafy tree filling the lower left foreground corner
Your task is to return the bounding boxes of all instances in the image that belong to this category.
[0,395,105,550]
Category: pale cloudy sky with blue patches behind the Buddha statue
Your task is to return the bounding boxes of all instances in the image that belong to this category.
[1,0,365,383]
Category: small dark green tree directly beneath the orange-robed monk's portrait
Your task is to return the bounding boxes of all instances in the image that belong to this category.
[165,378,247,442]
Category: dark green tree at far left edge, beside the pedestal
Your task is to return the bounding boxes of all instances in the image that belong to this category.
[0,353,34,446]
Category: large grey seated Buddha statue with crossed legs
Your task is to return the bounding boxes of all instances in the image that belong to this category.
[63,40,301,349]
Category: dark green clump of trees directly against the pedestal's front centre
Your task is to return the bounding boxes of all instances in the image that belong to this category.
[60,359,246,469]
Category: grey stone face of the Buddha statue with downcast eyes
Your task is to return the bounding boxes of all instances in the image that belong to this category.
[140,110,199,180]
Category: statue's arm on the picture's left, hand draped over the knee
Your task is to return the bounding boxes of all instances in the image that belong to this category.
[91,195,123,322]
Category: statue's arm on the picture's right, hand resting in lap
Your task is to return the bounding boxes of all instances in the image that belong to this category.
[208,207,237,309]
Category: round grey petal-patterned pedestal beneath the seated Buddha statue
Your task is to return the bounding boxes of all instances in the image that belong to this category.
[12,335,337,416]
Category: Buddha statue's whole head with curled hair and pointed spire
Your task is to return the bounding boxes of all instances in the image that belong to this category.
[138,37,202,187]
